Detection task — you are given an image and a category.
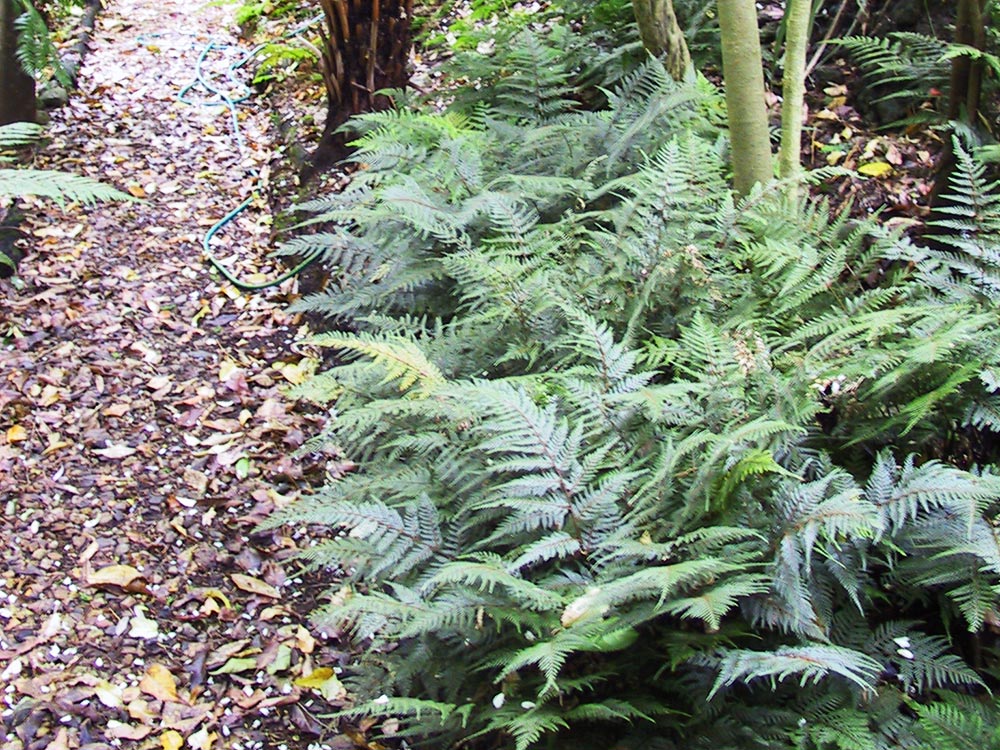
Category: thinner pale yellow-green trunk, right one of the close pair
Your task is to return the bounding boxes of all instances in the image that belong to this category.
[778,0,812,183]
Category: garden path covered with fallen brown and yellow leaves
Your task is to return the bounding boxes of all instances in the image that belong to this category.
[0,0,353,750]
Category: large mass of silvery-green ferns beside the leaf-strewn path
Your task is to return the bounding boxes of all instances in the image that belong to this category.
[271,11,1000,750]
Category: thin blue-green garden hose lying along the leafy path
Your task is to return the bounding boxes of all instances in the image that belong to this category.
[154,16,323,291]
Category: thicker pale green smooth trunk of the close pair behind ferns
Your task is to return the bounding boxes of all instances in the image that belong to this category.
[718,0,774,195]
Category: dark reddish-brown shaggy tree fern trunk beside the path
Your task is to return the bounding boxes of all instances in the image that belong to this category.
[305,0,413,178]
